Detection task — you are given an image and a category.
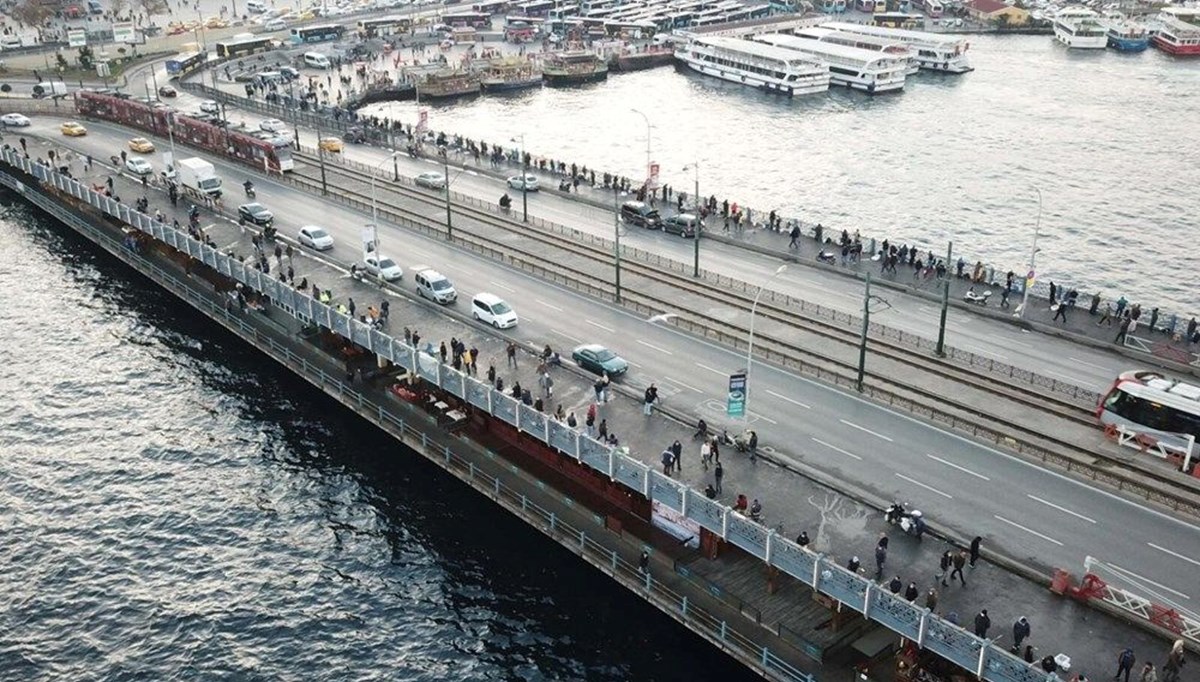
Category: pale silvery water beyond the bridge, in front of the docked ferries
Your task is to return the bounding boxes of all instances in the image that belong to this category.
[365,36,1200,312]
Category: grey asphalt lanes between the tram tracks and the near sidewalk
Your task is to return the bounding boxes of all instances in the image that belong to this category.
[30,119,1200,608]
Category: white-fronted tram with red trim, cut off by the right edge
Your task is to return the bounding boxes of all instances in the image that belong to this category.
[1096,371,1200,456]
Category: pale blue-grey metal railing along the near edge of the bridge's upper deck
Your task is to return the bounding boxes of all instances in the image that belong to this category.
[7,148,1099,682]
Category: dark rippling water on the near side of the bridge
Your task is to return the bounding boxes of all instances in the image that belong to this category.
[0,195,754,681]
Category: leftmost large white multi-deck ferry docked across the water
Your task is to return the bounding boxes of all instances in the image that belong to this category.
[674,36,829,97]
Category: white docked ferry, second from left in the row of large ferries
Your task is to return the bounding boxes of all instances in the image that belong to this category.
[754,34,908,95]
